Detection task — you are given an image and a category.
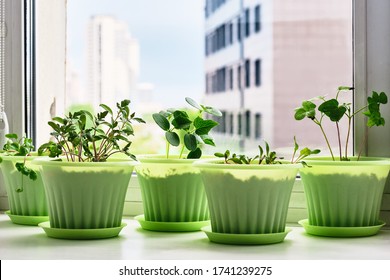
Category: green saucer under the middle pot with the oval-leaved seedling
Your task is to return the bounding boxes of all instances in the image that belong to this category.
[134,215,210,232]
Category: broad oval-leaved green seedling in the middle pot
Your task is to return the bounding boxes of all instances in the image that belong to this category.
[153,97,222,159]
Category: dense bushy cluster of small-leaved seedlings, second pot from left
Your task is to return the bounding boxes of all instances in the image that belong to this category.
[38,100,144,162]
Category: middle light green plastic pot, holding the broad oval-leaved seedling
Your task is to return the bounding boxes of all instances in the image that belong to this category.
[136,155,209,222]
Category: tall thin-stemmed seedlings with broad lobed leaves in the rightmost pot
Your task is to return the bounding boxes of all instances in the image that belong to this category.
[294,86,387,160]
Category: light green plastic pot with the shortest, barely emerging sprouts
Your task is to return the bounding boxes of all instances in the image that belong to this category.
[194,159,301,234]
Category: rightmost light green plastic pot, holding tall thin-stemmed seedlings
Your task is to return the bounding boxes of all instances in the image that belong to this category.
[300,157,390,227]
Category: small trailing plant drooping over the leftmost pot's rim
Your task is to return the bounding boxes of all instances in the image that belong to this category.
[0,133,37,192]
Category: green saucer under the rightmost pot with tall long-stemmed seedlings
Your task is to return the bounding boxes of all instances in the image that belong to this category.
[298,219,386,237]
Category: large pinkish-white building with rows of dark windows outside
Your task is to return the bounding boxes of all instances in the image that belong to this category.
[204,0,352,153]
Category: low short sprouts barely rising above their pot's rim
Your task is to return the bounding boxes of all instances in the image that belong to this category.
[214,137,320,165]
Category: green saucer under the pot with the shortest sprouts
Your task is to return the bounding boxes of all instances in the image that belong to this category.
[202,226,291,245]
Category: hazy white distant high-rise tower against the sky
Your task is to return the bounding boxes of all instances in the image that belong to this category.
[87,16,140,108]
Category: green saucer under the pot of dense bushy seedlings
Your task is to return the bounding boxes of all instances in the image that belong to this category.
[38,222,127,239]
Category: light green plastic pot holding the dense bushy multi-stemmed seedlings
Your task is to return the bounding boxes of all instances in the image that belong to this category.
[34,159,137,229]
